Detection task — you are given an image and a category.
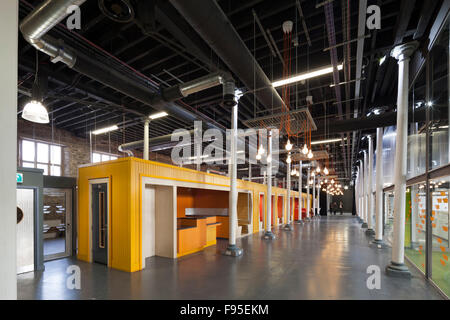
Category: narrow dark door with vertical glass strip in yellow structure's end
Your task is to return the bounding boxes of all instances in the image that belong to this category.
[91,183,108,265]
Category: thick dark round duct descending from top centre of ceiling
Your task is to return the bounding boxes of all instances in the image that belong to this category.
[170,0,283,109]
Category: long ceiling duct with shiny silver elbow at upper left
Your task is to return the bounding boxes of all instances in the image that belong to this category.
[20,0,227,130]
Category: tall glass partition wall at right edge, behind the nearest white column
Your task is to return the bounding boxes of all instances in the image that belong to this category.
[383,17,450,296]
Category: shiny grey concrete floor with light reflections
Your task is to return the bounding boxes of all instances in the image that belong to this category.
[18,216,442,300]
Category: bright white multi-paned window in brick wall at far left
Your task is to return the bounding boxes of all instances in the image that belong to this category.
[20,140,62,176]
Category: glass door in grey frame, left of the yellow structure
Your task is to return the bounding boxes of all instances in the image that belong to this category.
[43,188,72,261]
